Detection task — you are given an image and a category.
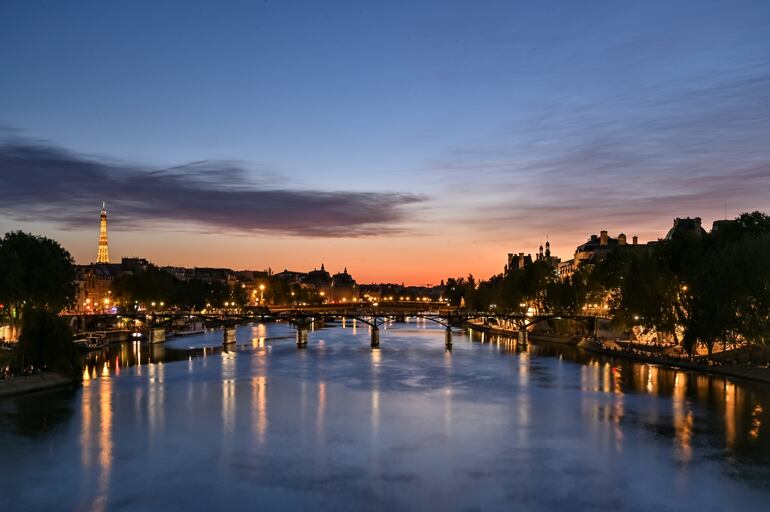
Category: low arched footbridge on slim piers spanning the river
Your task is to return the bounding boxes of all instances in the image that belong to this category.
[65,302,596,350]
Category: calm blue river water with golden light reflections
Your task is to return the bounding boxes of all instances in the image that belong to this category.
[0,322,770,511]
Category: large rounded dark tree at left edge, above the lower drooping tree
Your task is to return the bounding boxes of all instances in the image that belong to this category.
[0,231,77,324]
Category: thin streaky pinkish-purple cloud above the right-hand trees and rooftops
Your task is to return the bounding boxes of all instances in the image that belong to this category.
[420,68,770,243]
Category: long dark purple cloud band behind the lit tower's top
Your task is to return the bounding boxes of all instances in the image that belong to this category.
[0,141,424,237]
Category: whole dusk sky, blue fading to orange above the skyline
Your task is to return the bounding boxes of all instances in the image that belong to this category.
[0,0,770,284]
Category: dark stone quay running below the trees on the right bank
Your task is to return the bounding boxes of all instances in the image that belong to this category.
[468,323,770,384]
